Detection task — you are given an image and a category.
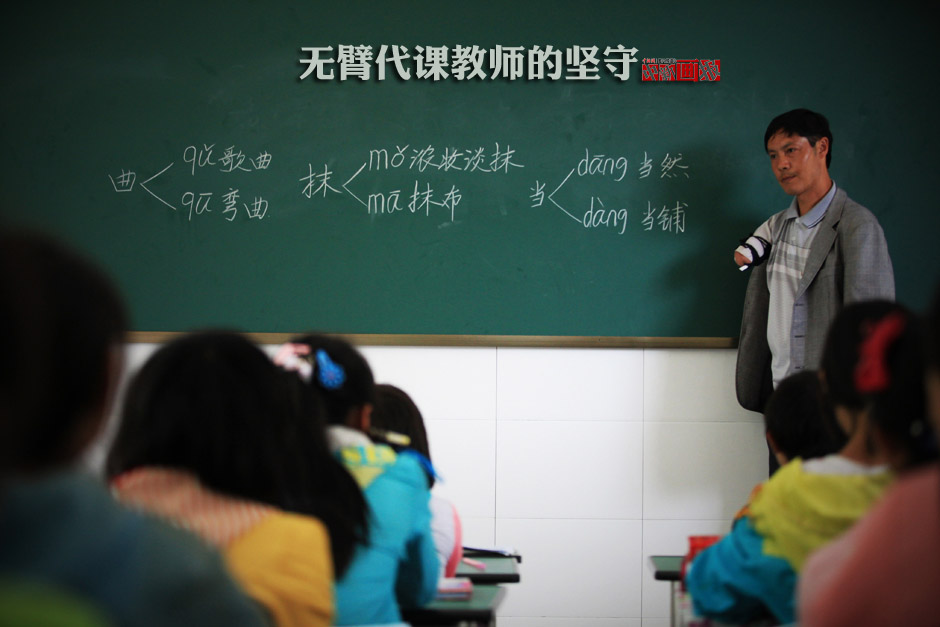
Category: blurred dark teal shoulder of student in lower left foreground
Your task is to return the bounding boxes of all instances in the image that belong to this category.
[5,473,261,625]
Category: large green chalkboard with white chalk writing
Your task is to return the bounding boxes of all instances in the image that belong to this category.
[0,0,940,338]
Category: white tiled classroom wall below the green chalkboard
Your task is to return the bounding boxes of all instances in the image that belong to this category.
[92,344,767,627]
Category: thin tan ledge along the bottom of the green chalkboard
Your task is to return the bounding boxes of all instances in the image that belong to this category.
[127,331,737,348]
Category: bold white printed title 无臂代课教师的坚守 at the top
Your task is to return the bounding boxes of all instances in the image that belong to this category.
[300,44,637,82]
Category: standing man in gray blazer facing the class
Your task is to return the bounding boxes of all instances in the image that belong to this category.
[735,109,894,412]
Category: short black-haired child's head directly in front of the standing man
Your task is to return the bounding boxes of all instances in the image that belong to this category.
[764,370,845,460]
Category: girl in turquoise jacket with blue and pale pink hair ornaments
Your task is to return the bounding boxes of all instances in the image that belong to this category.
[275,335,440,625]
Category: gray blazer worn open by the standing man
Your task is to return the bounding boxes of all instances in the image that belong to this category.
[735,188,894,412]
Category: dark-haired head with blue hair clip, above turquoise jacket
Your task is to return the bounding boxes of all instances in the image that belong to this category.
[292,334,375,425]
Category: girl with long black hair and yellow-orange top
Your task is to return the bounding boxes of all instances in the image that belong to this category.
[107,332,365,626]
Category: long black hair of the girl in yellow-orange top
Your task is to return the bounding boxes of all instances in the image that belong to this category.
[107,331,368,576]
